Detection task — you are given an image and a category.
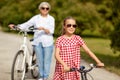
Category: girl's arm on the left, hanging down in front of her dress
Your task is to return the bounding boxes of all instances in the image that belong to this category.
[55,48,70,72]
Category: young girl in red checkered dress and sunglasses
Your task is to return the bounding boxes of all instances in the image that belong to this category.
[53,17,104,80]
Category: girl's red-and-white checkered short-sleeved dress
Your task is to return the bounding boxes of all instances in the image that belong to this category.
[53,35,84,80]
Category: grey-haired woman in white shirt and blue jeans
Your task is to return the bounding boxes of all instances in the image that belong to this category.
[9,2,55,80]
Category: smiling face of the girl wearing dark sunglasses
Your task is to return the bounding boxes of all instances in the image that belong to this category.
[64,19,77,35]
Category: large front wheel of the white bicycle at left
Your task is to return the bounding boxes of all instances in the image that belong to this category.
[11,50,26,80]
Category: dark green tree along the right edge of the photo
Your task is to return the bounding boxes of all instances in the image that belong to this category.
[110,0,120,52]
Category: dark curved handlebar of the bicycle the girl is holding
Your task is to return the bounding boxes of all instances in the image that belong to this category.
[70,64,96,73]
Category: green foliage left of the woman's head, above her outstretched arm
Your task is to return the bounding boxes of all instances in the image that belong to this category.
[0,0,43,31]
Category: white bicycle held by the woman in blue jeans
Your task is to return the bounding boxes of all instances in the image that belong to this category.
[11,26,39,80]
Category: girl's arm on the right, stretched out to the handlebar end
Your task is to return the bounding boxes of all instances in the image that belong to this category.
[82,43,104,67]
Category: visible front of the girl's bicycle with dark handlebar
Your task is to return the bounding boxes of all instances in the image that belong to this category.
[70,64,96,80]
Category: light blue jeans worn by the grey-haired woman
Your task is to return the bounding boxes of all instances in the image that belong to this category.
[34,43,53,78]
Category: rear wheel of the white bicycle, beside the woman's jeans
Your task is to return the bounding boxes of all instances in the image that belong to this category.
[31,51,39,78]
